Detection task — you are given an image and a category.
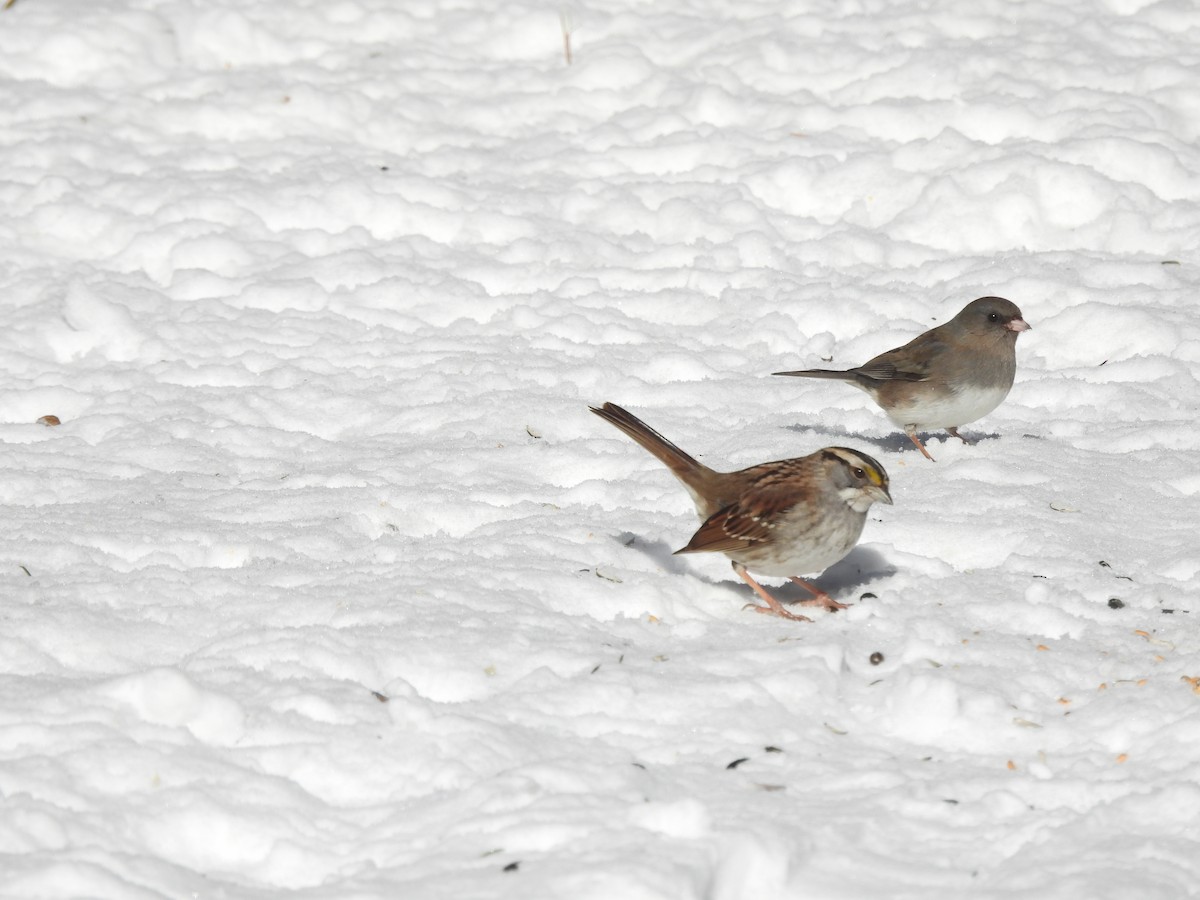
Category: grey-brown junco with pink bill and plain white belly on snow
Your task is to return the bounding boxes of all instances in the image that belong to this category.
[775,296,1030,462]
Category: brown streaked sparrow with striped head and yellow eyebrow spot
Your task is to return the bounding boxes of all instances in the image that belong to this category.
[590,403,892,622]
